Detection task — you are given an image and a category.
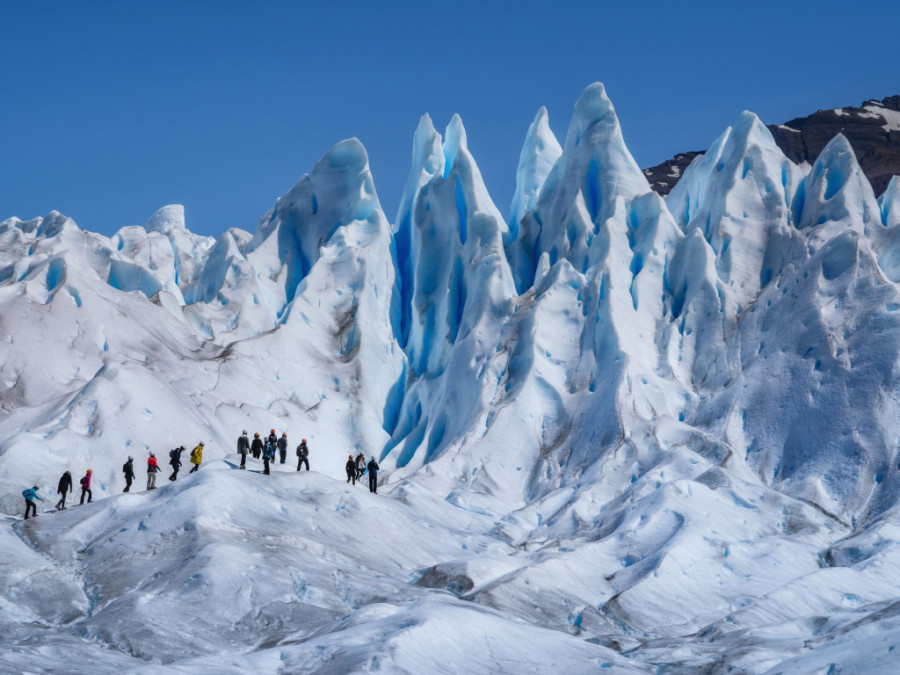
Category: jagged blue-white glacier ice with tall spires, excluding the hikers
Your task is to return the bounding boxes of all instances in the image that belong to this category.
[0,84,900,673]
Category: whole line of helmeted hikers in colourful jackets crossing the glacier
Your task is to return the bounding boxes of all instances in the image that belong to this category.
[22,429,344,520]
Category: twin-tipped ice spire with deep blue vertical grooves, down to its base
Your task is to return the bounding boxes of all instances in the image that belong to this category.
[385,115,515,470]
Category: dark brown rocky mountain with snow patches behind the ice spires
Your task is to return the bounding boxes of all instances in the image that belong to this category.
[643,96,900,196]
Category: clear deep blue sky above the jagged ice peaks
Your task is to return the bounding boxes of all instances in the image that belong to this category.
[0,0,900,235]
